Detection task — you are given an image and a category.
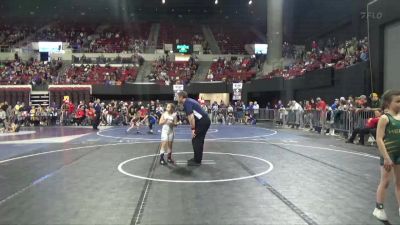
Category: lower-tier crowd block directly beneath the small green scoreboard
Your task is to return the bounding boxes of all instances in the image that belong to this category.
[147,55,198,85]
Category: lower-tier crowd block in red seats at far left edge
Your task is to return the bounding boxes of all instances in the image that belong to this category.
[0,59,62,86]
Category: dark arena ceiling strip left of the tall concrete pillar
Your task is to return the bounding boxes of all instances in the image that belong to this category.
[0,0,266,21]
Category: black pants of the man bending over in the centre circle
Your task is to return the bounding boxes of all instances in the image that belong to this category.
[192,117,211,163]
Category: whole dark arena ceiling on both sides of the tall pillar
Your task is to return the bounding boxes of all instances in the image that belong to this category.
[0,0,371,42]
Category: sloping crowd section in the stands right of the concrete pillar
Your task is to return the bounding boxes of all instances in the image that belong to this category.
[265,38,369,79]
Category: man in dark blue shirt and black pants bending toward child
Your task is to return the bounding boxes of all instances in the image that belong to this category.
[177,91,211,166]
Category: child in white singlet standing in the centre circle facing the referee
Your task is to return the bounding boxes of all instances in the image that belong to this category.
[160,103,178,165]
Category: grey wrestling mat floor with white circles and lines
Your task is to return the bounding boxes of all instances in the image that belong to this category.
[0,125,400,225]
